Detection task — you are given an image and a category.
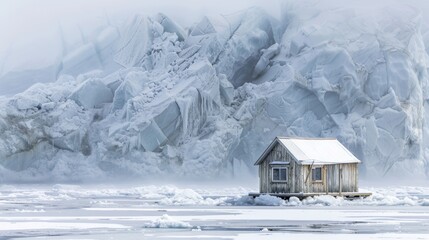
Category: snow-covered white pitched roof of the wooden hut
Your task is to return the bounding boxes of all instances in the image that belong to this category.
[255,137,360,165]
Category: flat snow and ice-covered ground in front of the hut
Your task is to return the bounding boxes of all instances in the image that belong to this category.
[0,185,429,239]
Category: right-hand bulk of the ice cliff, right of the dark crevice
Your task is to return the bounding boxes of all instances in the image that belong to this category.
[231,5,428,176]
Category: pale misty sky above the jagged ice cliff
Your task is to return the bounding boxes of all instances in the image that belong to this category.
[0,0,429,76]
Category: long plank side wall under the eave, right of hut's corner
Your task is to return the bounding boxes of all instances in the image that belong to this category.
[301,163,358,193]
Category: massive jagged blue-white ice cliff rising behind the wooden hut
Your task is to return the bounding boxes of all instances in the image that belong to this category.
[0,3,429,181]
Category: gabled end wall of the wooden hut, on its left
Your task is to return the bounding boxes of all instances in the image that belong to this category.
[259,142,300,193]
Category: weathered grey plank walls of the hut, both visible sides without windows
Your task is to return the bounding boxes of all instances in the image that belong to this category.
[259,142,358,193]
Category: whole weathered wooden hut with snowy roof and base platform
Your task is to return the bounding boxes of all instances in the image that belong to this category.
[250,137,370,198]
